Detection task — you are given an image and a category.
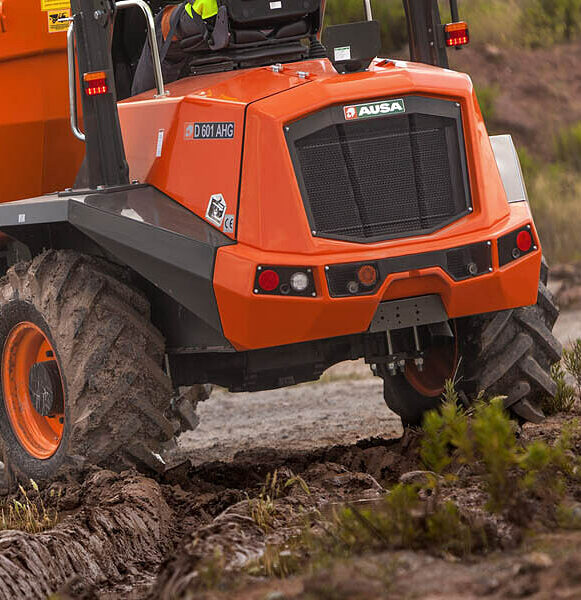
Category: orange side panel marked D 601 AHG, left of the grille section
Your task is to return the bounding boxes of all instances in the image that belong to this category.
[119,69,305,239]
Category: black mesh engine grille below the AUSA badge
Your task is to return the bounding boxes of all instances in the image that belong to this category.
[285,96,472,243]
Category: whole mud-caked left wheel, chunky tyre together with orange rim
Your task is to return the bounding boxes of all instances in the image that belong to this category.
[0,250,175,482]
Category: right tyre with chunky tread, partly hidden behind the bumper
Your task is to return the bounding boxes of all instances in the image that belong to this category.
[380,262,562,426]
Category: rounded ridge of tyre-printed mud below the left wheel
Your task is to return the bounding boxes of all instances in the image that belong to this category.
[0,471,175,599]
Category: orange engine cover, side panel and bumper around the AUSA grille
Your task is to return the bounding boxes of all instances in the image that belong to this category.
[120,60,541,350]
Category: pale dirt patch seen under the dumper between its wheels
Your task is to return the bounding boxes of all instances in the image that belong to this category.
[179,361,402,464]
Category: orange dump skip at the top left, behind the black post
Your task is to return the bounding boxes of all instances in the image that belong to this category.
[0,0,85,202]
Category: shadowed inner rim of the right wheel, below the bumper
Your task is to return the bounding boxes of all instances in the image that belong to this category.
[405,326,458,398]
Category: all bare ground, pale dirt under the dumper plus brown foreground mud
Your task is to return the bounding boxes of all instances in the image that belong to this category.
[0,290,581,600]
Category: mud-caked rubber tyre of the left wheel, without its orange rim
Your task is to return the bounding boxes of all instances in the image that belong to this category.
[0,250,174,481]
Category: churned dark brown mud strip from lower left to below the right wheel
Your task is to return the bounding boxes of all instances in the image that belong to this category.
[0,432,411,599]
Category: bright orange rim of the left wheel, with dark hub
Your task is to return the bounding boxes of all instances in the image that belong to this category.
[2,321,65,460]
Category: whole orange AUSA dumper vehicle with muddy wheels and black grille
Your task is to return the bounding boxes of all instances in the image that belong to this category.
[0,0,561,481]
